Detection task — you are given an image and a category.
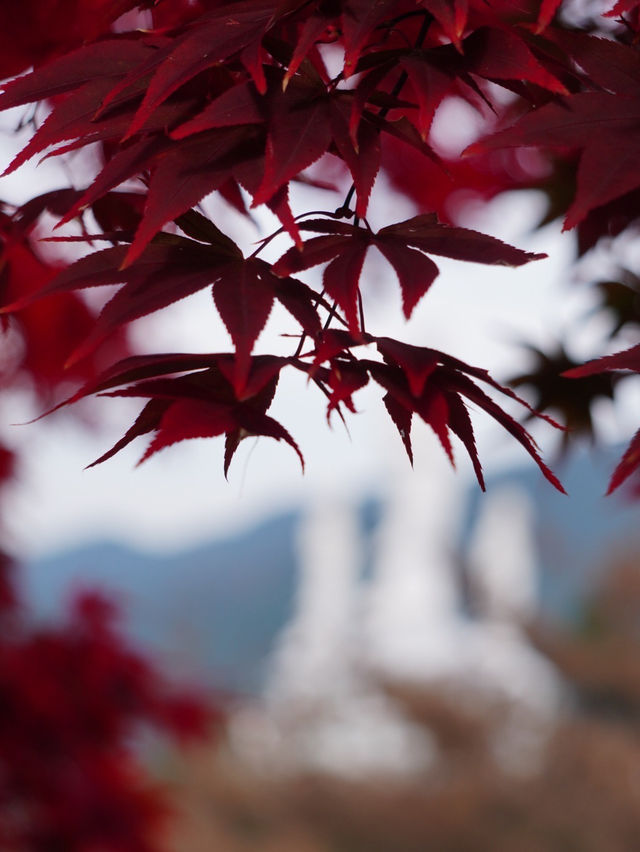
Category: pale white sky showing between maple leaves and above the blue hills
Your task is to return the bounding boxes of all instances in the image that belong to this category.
[0,98,637,554]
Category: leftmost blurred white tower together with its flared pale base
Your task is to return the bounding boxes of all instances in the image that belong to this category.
[266,495,436,774]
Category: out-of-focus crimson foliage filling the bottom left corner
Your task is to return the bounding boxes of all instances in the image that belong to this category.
[0,553,217,852]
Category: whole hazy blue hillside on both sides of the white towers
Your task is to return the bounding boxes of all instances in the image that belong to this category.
[19,448,640,694]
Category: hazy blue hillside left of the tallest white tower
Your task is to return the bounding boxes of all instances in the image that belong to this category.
[18,500,380,693]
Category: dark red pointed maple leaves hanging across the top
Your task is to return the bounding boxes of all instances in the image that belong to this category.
[0,0,640,488]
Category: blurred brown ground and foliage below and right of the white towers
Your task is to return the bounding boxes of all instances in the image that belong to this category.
[161,558,640,852]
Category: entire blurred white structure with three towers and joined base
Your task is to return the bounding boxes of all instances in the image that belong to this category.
[258,435,558,772]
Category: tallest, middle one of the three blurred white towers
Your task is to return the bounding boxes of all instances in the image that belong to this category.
[365,435,461,676]
